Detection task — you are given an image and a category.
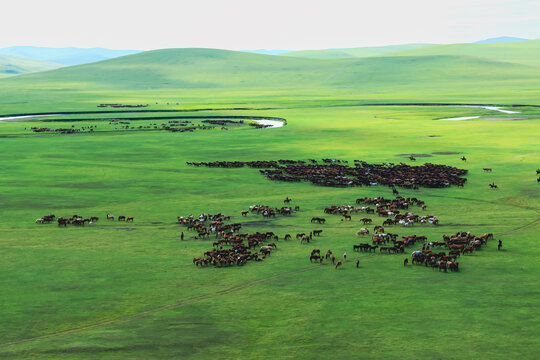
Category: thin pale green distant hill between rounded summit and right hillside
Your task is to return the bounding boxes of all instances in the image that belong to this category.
[282,44,433,59]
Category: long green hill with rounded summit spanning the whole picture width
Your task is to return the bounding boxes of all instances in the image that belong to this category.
[0,45,538,91]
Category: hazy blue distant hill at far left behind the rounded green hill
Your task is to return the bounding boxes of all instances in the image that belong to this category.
[0,46,140,65]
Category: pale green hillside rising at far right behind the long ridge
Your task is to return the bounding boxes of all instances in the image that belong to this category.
[391,39,540,64]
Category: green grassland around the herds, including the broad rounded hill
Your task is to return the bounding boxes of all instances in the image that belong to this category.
[0,46,540,359]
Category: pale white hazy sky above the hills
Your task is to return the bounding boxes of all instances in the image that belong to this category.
[0,0,540,50]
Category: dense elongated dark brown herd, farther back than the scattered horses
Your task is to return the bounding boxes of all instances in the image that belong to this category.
[187,159,467,189]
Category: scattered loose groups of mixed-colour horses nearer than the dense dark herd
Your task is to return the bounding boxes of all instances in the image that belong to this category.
[32,191,502,272]
